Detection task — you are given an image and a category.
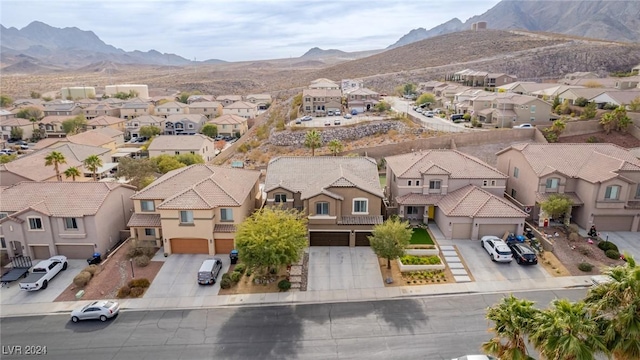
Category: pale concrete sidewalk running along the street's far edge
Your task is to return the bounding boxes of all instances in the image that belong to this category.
[0,276,591,317]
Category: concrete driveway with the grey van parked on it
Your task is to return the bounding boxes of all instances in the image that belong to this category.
[144,251,231,299]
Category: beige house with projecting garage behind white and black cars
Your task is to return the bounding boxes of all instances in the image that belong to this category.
[385,150,527,240]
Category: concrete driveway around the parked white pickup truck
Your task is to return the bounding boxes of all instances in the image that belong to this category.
[0,259,87,305]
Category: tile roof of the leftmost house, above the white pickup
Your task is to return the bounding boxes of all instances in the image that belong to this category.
[0,181,133,221]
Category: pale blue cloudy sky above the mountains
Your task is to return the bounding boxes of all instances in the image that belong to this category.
[0,0,499,61]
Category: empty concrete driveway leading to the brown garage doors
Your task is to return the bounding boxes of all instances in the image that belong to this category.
[307,246,384,291]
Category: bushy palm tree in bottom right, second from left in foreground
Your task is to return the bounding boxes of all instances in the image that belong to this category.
[529,299,609,360]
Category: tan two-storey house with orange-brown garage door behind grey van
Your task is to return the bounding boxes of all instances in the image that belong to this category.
[128,164,261,255]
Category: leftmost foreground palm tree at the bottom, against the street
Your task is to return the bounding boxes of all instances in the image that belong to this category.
[482,295,540,360]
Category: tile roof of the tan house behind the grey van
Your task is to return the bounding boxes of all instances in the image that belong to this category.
[131,164,260,209]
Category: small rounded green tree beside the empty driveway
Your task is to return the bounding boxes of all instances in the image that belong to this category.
[369,217,413,269]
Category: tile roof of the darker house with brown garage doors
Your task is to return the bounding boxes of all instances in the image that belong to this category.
[265,156,383,199]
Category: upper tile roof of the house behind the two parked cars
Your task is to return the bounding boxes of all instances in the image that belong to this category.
[385,149,507,179]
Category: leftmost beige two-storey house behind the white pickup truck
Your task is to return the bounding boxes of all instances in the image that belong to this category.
[0,181,135,260]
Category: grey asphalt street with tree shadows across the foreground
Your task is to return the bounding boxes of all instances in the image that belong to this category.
[0,289,586,360]
